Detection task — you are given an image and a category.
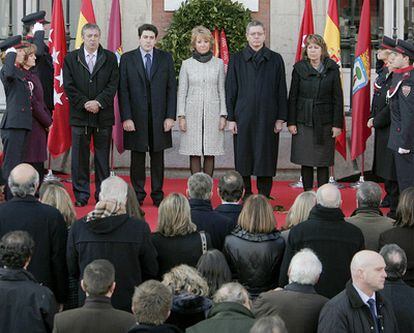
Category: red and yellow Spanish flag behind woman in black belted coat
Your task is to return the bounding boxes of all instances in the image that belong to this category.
[323,0,346,160]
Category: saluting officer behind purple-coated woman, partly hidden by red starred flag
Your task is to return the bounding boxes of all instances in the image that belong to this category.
[22,10,54,112]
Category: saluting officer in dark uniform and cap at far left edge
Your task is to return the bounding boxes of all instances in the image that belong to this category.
[0,35,32,200]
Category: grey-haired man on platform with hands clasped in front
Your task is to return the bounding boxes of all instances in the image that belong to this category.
[63,23,119,206]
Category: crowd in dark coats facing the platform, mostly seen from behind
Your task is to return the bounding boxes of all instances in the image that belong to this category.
[0,163,414,333]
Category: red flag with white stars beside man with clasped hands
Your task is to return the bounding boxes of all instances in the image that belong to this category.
[48,0,72,157]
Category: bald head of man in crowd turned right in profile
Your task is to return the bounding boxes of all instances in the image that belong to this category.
[351,250,387,296]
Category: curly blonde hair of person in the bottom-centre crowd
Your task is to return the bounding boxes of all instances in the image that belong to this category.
[162,265,209,296]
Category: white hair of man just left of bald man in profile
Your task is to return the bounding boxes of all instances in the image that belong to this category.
[289,248,322,285]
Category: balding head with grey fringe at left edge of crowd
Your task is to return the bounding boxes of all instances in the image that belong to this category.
[8,163,39,198]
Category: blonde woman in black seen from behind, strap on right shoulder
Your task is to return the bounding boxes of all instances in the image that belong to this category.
[152,193,212,278]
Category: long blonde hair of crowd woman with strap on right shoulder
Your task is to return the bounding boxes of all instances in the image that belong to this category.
[157,193,197,237]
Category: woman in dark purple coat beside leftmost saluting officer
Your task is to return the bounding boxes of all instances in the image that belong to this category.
[22,44,52,181]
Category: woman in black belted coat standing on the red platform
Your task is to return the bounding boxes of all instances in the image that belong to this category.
[288,35,344,191]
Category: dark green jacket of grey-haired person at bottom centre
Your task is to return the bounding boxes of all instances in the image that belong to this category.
[186,302,254,333]
